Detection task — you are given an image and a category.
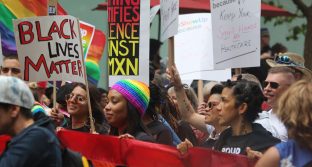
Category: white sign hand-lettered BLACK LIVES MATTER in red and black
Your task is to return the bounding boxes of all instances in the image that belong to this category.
[13,15,85,83]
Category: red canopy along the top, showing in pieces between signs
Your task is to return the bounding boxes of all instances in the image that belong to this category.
[95,0,293,16]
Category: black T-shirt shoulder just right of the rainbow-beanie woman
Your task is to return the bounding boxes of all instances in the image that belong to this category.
[146,120,173,145]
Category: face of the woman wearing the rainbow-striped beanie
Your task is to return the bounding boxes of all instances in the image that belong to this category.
[104,89,128,128]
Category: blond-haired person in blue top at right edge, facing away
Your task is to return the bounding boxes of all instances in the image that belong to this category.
[256,80,312,167]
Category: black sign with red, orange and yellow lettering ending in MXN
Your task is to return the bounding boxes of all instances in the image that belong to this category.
[107,0,150,86]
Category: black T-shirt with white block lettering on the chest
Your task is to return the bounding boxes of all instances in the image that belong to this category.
[214,123,280,155]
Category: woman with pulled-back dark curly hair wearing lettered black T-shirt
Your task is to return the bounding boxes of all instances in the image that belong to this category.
[214,80,280,154]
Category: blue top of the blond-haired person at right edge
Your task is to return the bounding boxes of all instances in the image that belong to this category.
[275,139,312,166]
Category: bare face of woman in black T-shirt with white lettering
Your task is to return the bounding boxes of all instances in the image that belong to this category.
[219,88,239,126]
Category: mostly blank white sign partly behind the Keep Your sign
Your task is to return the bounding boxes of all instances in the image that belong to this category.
[174,13,231,81]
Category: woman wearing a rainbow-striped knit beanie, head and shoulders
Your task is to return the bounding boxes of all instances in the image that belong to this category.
[104,79,155,142]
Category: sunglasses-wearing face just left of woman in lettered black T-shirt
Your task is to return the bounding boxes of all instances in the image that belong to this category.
[204,94,221,125]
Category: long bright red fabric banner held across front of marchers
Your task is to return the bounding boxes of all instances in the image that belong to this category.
[58,131,254,167]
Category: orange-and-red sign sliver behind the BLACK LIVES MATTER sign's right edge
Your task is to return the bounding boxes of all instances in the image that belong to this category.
[79,20,95,59]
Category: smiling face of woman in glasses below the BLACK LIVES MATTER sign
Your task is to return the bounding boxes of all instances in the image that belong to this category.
[66,86,89,116]
